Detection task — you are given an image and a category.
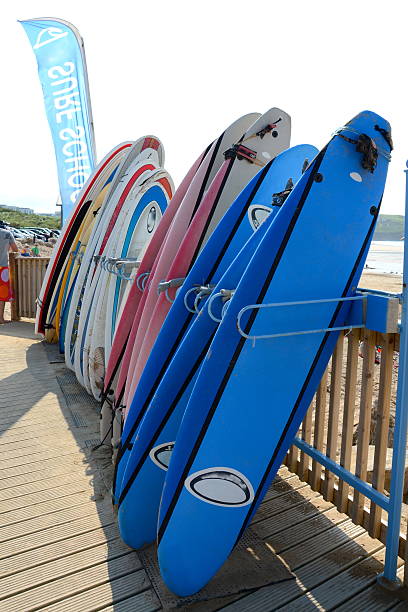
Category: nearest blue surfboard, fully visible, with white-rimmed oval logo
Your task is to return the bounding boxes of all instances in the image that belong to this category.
[158,111,392,596]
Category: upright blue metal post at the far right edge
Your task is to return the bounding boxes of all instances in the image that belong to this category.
[380,162,408,584]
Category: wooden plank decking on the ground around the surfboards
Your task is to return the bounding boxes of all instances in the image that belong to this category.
[0,322,408,612]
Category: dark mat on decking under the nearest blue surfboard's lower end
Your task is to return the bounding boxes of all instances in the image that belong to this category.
[137,528,295,612]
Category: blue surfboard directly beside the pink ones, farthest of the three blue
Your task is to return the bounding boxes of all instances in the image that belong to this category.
[113,145,317,510]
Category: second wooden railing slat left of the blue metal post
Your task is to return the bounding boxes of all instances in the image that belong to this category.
[351,330,375,525]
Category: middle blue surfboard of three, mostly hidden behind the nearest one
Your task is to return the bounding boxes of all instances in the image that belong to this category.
[118,209,273,549]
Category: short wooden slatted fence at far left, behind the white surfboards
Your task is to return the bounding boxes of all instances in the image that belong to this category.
[9,253,50,321]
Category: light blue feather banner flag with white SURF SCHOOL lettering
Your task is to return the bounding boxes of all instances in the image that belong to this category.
[20,18,95,222]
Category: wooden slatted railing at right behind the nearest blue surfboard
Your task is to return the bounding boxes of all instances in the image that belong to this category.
[285,329,408,556]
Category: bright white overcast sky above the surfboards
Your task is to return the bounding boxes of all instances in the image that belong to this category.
[0,0,408,214]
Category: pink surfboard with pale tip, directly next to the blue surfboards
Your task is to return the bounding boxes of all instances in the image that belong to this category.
[124,108,290,418]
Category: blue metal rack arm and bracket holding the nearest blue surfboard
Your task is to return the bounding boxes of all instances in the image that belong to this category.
[234,289,400,344]
